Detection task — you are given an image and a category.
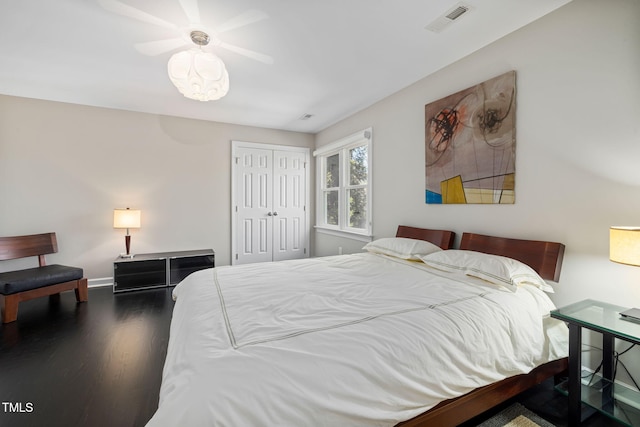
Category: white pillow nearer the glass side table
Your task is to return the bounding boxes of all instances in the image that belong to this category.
[420,249,553,293]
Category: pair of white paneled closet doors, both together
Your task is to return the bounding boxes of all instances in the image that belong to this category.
[231,141,309,264]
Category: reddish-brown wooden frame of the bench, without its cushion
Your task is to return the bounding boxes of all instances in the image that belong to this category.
[0,233,89,323]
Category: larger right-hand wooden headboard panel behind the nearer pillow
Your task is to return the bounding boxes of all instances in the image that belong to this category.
[460,233,564,282]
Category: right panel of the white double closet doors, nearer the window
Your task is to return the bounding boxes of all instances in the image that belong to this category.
[272,150,307,261]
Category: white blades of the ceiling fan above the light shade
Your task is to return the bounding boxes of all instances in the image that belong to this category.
[98,0,273,64]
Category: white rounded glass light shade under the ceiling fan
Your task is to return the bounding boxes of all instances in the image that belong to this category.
[168,47,229,101]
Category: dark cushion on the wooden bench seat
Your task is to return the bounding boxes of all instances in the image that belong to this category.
[0,264,84,295]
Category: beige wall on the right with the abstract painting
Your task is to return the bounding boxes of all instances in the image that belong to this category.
[316,0,640,306]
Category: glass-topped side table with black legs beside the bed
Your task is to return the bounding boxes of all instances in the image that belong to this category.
[551,300,640,426]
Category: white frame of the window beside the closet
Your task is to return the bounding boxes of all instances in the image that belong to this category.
[313,128,373,242]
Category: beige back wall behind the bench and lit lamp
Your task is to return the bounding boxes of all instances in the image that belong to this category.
[0,96,314,283]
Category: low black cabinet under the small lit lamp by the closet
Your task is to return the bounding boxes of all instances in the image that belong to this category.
[113,249,215,293]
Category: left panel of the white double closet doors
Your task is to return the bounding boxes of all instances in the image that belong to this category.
[232,148,273,264]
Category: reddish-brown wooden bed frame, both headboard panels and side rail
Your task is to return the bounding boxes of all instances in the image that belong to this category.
[396,225,568,427]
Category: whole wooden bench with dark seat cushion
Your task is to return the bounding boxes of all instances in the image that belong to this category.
[0,233,89,323]
